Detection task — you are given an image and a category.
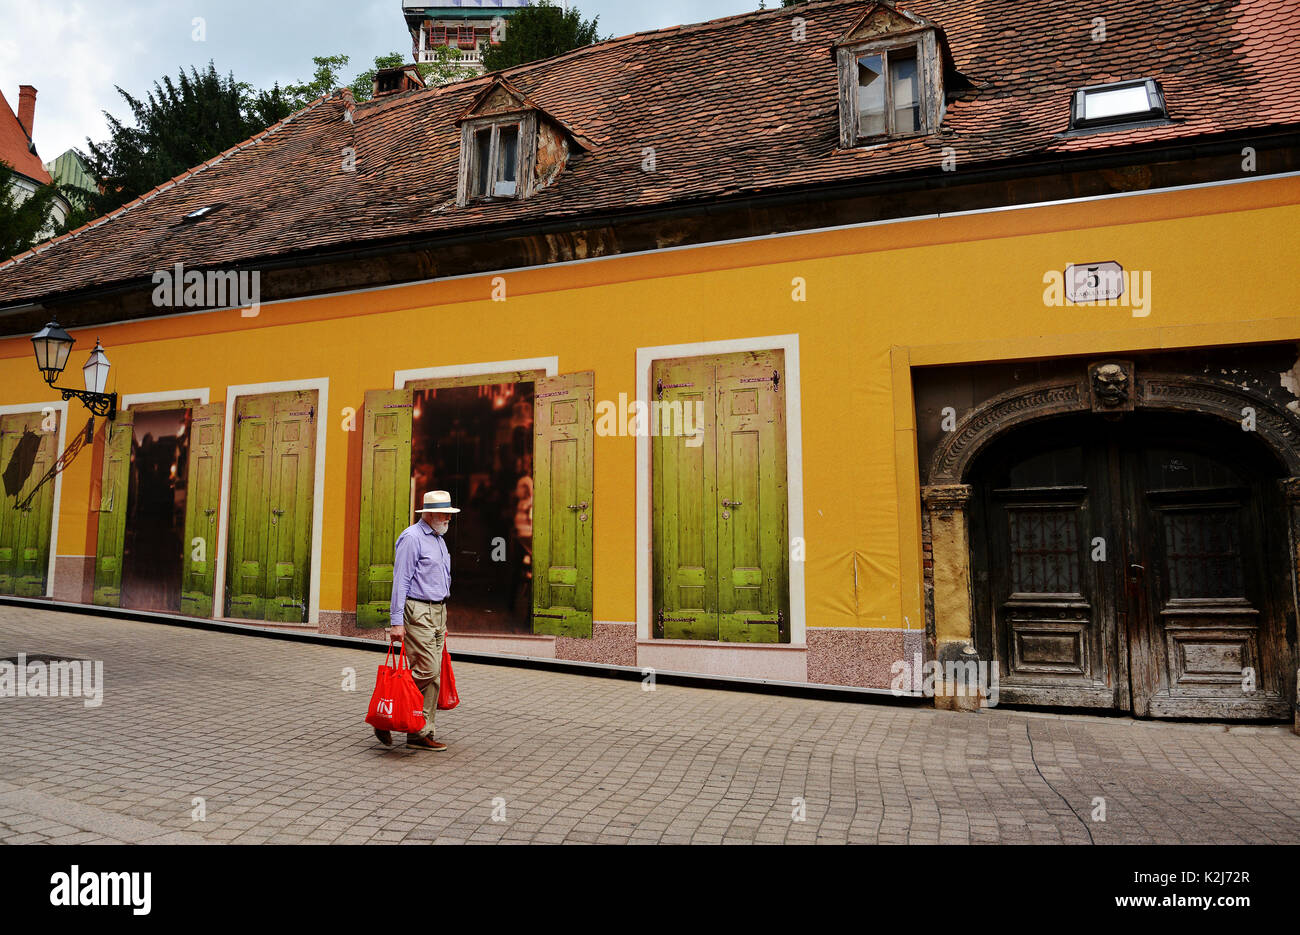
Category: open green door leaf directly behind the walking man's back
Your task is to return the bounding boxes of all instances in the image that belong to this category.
[356,390,415,628]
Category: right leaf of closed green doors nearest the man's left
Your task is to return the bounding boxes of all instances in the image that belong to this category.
[264,390,320,623]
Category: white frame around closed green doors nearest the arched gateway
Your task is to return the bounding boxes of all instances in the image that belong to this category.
[636,334,807,646]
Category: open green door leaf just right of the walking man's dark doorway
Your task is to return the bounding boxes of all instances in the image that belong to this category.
[533,371,595,637]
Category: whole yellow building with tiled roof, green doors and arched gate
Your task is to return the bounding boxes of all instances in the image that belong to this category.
[0,0,1300,719]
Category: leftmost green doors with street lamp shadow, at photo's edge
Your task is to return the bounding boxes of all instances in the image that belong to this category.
[0,410,61,597]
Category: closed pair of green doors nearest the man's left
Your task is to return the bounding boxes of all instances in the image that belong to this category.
[226,390,319,623]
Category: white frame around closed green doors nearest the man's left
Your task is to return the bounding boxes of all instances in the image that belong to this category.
[212,377,329,626]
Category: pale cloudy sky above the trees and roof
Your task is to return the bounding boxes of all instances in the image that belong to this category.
[0,0,759,163]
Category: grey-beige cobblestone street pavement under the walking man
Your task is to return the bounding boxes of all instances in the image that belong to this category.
[0,607,1300,844]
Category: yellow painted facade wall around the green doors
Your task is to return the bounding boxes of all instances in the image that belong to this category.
[0,173,1300,717]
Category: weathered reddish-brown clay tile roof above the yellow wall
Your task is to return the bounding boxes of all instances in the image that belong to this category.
[0,0,1300,304]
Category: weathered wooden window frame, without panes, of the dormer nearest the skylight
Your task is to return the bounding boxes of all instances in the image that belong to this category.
[837,30,944,150]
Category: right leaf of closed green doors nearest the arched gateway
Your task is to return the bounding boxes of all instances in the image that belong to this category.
[714,352,789,642]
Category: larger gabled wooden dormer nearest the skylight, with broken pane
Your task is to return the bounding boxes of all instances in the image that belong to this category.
[835,4,944,150]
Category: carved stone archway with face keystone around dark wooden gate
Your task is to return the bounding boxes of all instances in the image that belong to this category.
[922,360,1300,710]
